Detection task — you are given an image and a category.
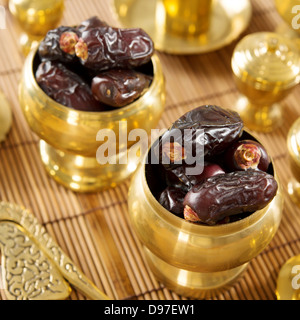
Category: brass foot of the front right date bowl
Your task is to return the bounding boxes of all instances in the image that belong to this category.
[144,247,248,299]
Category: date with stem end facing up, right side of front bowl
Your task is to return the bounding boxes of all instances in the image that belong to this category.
[225,140,270,171]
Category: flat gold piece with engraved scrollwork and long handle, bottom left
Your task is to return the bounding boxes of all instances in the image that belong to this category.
[0,202,108,300]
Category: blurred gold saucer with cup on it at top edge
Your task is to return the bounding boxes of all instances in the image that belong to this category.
[112,0,252,55]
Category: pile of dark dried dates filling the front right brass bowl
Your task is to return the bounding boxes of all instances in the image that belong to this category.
[146,105,278,225]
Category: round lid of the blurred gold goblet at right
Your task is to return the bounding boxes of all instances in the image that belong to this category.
[232,32,300,90]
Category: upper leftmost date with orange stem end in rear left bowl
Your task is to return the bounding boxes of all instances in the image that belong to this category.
[38,26,80,62]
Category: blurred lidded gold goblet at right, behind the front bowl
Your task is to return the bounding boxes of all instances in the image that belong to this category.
[232,32,300,132]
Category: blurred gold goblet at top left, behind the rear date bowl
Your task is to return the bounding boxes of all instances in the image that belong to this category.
[8,0,64,55]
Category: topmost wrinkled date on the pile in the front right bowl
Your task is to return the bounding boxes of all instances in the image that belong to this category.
[159,105,244,168]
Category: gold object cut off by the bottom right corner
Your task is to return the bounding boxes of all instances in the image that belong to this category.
[276,255,300,300]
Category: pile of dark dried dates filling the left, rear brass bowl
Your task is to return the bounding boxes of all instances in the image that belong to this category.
[35,17,154,111]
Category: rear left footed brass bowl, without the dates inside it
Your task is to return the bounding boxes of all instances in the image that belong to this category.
[19,49,165,192]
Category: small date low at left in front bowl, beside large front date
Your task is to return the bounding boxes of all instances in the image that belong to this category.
[159,187,186,217]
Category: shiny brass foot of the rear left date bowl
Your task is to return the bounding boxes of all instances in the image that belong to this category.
[40,140,138,192]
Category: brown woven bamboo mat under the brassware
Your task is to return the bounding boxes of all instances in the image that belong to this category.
[0,0,300,300]
